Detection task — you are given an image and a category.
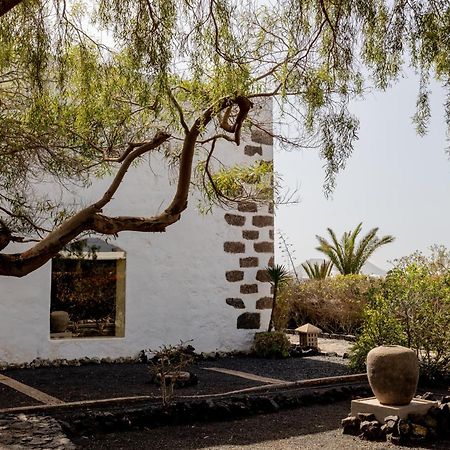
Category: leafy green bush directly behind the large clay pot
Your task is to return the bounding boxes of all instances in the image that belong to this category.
[350,264,450,380]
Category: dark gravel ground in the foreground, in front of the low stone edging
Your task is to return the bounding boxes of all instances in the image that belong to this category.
[75,401,450,450]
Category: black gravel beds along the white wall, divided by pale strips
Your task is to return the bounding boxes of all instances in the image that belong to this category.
[0,356,348,408]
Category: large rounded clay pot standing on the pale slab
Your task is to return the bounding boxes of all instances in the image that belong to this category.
[367,345,419,406]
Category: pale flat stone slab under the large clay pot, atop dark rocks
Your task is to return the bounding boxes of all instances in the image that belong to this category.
[351,397,437,423]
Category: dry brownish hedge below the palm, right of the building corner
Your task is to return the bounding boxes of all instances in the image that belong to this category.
[275,275,382,334]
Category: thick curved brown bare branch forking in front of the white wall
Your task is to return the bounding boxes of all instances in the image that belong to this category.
[0,96,252,277]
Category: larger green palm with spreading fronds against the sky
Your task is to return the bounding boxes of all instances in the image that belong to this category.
[316,223,394,275]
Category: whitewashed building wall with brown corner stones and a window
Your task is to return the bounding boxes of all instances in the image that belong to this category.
[0,101,273,363]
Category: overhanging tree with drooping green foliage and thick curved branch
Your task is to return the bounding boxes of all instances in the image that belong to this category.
[0,0,450,277]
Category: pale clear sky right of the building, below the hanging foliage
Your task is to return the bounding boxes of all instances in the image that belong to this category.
[274,73,450,270]
